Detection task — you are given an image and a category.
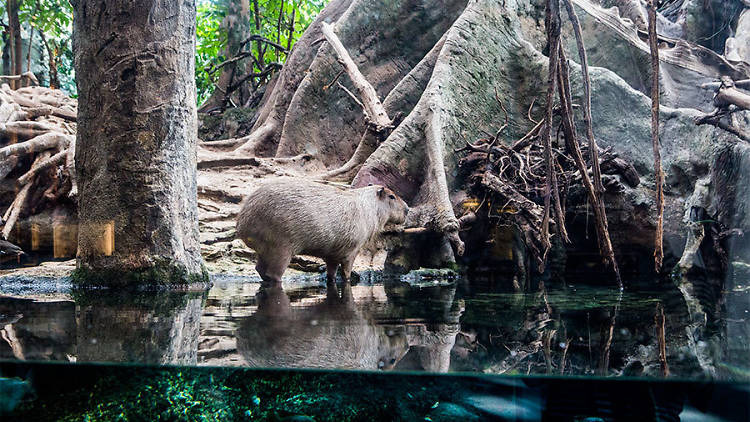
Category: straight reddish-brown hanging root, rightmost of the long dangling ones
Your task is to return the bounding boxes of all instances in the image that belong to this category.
[648,0,664,273]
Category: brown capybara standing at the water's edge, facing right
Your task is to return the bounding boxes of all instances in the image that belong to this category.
[237,177,409,285]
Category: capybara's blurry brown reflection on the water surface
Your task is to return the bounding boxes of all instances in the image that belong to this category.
[236,283,409,370]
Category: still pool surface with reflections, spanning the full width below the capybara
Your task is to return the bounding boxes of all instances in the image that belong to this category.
[0,273,750,380]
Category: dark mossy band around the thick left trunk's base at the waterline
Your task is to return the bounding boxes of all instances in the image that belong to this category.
[70,259,208,287]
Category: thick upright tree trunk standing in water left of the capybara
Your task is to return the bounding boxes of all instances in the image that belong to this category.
[72,0,207,285]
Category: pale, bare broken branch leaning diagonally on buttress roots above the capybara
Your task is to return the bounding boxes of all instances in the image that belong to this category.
[321,22,393,131]
